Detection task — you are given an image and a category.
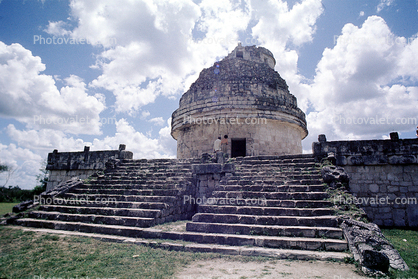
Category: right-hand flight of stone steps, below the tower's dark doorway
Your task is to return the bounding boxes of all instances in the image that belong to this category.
[186,155,348,251]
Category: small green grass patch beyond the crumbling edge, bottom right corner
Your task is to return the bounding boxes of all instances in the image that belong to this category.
[382,229,418,278]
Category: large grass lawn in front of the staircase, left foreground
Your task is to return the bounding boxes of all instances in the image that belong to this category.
[0,227,267,279]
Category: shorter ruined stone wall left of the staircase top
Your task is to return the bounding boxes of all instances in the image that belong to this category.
[46,144,133,190]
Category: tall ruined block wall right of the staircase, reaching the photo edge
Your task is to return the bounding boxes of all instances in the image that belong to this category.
[313,139,418,227]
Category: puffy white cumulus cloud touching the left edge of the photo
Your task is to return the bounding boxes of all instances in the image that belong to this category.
[0,42,105,134]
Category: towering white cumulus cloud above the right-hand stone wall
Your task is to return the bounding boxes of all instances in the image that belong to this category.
[307,16,418,149]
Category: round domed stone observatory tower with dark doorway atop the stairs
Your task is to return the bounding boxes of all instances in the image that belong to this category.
[171,44,308,159]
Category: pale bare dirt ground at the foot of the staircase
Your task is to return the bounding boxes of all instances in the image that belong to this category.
[175,259,368,279]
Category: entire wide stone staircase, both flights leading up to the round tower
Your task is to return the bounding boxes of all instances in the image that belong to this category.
[15,155,348,258]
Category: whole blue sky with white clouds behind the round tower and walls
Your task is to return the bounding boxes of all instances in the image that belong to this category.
[0,0,418,189]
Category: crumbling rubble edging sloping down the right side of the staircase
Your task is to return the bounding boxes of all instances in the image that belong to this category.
[321,160,409,276]
